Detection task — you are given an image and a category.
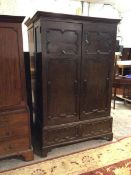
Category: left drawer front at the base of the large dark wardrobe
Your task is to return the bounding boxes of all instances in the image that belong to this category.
[43,126,78,145]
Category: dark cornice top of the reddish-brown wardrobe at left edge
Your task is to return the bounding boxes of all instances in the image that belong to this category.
[0,15,25,23]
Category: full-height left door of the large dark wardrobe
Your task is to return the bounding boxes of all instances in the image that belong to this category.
[42,21,81,125]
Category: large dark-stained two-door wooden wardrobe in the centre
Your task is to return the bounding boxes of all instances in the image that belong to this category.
[26,12,119,156]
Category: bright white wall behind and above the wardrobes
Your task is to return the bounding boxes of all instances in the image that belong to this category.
[0,0,131,51]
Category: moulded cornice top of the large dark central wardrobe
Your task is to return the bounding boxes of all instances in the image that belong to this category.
[25,11,120,26]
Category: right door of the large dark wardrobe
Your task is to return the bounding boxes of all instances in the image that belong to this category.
[80,22,116,119]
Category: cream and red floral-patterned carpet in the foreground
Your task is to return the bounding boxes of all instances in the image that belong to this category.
[0,137,131,175]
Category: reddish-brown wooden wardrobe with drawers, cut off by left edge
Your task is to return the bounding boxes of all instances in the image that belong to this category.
[0,15,33,160]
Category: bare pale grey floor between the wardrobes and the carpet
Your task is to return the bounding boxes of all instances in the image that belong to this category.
[0,101,131,171]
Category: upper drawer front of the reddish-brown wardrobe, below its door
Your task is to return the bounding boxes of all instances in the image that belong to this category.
[0,114,29,139]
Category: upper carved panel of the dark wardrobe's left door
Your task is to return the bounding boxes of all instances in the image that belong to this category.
[44,21,81,57]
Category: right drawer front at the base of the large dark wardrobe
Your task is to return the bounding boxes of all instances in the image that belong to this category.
[80,119,112,137]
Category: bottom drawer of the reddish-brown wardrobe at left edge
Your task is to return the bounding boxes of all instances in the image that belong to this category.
[0,137,29,156]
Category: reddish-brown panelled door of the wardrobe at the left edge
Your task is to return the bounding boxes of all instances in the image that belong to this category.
[0,22,25,110]
